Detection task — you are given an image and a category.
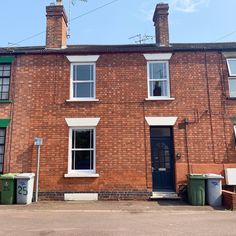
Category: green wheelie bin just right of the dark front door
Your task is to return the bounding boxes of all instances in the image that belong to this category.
[188,174,205,206]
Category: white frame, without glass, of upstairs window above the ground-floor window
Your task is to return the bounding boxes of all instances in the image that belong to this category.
[70,62,96,101]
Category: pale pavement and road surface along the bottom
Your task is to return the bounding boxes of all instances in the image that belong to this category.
[0,200,236,236]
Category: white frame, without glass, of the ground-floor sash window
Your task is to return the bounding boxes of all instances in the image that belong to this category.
[68,126,96,174]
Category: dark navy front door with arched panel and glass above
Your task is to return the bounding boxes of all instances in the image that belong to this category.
[151,127,174,191]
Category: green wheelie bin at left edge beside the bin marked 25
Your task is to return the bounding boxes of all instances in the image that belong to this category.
[0,173,16,204]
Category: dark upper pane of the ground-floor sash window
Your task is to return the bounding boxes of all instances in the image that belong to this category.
[73,130,93,148]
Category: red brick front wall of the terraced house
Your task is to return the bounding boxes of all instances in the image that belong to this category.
[0,52,236,196]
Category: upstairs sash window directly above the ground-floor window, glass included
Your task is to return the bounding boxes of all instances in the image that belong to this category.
[71,63,95,99]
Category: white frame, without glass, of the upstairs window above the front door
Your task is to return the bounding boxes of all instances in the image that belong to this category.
[147,60,170,100]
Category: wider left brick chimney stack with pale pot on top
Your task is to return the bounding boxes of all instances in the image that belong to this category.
[46,0,68,48]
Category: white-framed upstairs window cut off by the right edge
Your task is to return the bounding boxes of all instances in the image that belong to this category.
[227,58,236,97]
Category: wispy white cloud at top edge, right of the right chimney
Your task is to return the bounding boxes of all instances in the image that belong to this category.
[169,0,210,13]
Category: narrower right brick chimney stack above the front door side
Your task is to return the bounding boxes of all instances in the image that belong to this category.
[153,3,169,47]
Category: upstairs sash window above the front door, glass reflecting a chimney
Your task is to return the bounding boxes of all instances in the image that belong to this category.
[148,61,170,98]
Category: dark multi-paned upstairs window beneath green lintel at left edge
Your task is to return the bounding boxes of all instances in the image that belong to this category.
[0,64,11,100]
